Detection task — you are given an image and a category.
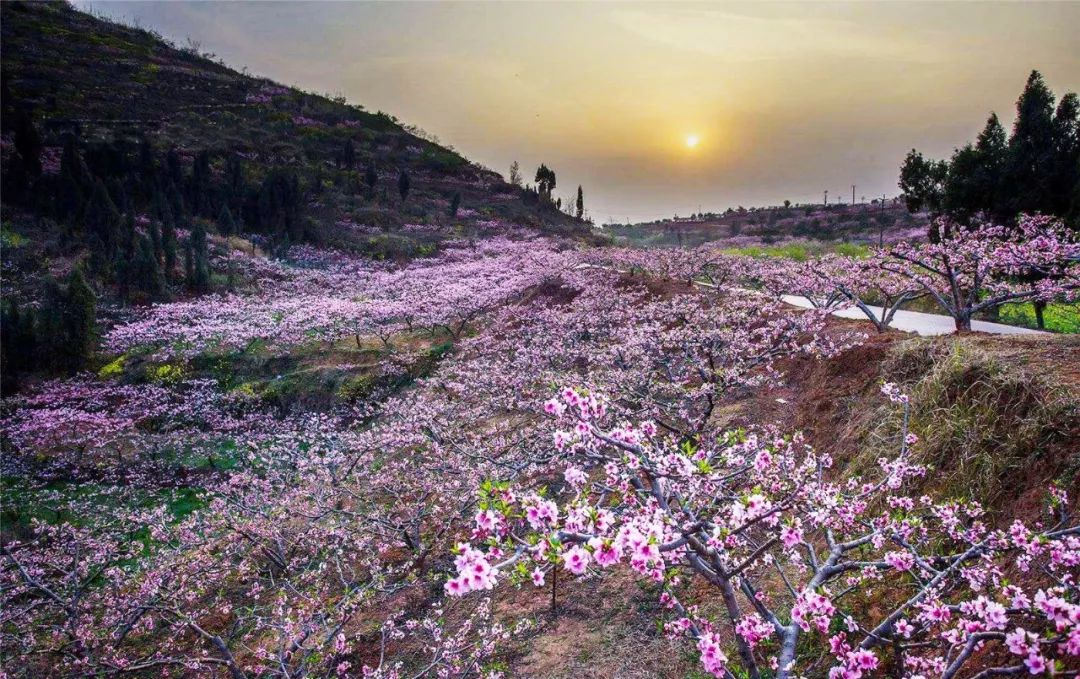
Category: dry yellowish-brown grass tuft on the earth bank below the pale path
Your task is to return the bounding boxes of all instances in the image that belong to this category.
[851,339,1080,505]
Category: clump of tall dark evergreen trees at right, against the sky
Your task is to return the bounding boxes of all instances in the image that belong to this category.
[900,71,1080,241]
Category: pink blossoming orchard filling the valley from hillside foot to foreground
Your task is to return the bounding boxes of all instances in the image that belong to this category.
[0,220,1080,679]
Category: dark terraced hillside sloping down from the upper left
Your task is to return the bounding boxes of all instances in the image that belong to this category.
[2,2,589,266]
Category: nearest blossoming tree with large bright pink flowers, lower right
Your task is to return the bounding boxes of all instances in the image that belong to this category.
[446,384,1080,677]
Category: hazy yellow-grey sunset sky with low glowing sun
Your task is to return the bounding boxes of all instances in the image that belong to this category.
[79,2,1080,221]
